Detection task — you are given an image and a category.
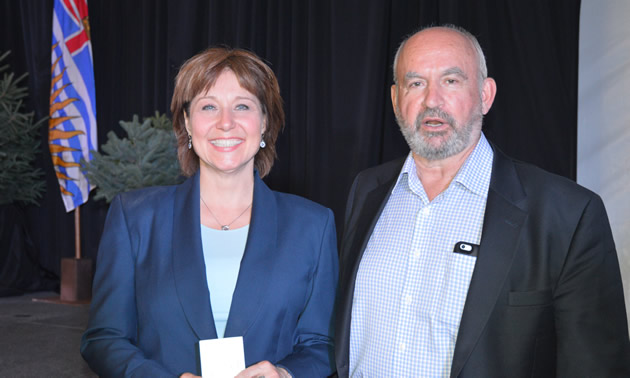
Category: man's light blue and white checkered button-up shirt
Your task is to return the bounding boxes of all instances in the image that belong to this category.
[350,134,493,377]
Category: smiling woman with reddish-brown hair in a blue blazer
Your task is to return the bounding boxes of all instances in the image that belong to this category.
[81,48,338,377]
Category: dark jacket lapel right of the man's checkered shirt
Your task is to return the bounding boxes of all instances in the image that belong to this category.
[451,148,527,377]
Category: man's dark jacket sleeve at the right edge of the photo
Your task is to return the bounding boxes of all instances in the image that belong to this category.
[554,195,630,377]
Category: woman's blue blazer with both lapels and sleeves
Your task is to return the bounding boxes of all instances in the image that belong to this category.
[81,173,338,377]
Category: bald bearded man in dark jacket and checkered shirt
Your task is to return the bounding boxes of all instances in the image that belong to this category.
[336,26,630,377]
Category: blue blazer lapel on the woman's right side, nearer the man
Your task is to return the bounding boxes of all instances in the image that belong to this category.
[225,172,281,337]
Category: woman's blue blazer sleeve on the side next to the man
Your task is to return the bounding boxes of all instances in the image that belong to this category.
[278,209,339,377]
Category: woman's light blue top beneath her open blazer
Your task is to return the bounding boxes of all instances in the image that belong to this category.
[201,225,249,338]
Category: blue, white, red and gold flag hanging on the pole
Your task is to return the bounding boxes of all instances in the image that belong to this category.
[48,0,97,212]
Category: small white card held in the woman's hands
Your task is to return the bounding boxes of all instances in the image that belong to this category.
[199,336,245,378]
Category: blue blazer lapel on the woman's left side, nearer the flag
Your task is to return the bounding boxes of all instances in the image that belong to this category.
[171,172,217,340]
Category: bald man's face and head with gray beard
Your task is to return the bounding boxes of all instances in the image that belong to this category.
[392,28,494,161]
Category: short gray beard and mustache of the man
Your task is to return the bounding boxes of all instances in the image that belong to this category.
[396,107,483,161]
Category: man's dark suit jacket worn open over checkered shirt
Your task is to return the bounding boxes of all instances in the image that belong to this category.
[335,148,630,377]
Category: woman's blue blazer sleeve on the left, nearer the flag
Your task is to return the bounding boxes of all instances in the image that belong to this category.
[81,196,175,377]
